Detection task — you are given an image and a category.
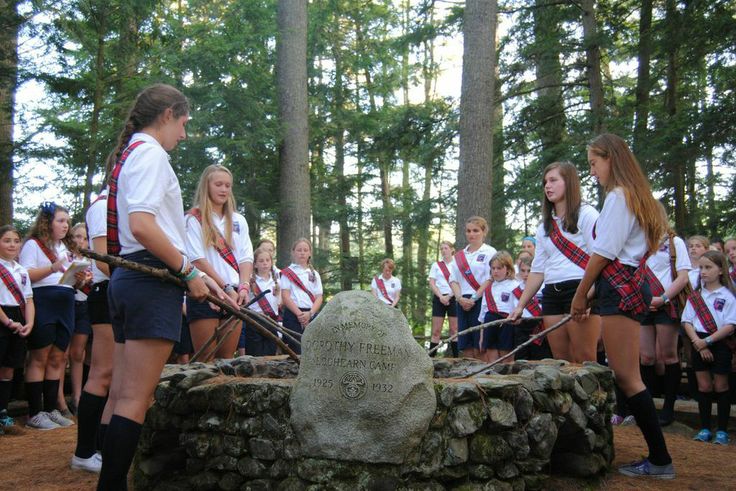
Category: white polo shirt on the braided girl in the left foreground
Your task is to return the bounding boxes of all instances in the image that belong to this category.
[117,133,186,254]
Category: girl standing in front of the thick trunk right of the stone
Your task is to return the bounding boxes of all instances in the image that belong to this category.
[450,216,496,359]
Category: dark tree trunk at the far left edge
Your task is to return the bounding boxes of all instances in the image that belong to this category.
[0,0,21,224]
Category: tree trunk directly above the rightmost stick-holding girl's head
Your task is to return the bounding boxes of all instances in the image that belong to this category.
[580,0,606,135]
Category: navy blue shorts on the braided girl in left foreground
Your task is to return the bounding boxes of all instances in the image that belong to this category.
[107,251,184,343]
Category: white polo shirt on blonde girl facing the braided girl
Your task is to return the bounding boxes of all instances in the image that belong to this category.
[186,213,253,285]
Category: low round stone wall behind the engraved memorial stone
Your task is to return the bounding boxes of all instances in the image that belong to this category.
[134,356,614,491]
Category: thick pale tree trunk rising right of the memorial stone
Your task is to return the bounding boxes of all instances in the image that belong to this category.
[455,0,497,247]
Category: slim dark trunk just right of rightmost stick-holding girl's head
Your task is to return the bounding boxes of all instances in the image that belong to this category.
[633,0,653,161]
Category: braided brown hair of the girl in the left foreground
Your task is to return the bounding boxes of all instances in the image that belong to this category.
[106,84,189,179]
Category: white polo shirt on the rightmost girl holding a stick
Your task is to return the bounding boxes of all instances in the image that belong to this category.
[593,187,647,266]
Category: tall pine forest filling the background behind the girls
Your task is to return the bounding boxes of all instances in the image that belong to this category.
[0,0,736,334]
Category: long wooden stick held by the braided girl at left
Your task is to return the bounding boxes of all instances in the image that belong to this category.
[80,249,299,363]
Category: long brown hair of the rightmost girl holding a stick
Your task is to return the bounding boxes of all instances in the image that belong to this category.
[588,133,668,253]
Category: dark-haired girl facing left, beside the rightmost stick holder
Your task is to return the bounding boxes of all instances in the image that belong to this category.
[509,162,601,363]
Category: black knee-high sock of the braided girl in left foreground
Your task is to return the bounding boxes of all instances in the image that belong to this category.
[97,414,142,491]
